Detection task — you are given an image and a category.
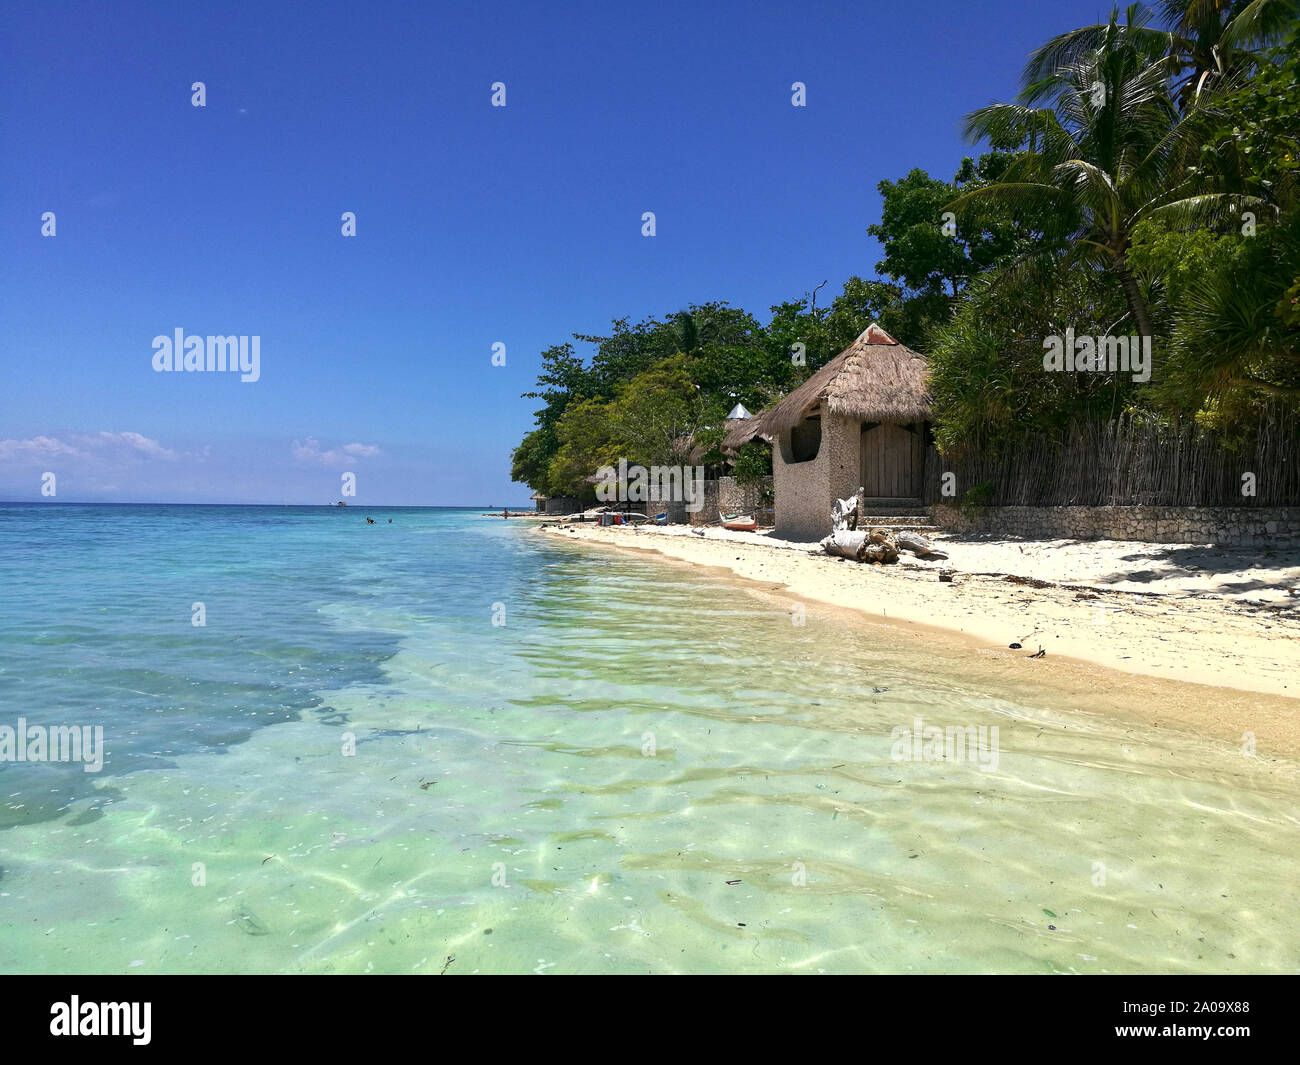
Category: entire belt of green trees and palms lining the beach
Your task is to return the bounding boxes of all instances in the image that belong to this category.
[511,0,1300,497]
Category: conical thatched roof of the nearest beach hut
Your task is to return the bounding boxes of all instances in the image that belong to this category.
[727,322,930,446]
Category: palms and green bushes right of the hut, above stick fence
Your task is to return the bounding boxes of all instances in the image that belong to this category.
[926,0,1300,453]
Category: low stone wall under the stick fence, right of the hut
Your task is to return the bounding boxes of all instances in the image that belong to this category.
[930,503,1300,546]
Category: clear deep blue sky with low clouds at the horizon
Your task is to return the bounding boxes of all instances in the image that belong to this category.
[0,0,1106,506]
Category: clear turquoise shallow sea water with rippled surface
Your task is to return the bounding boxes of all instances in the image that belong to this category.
[0,506,1300,974]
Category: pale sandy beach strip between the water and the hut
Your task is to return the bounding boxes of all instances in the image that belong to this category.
[542,524,1300,758]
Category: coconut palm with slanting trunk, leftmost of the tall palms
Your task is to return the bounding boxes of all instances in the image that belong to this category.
[952,7,1255,335]
